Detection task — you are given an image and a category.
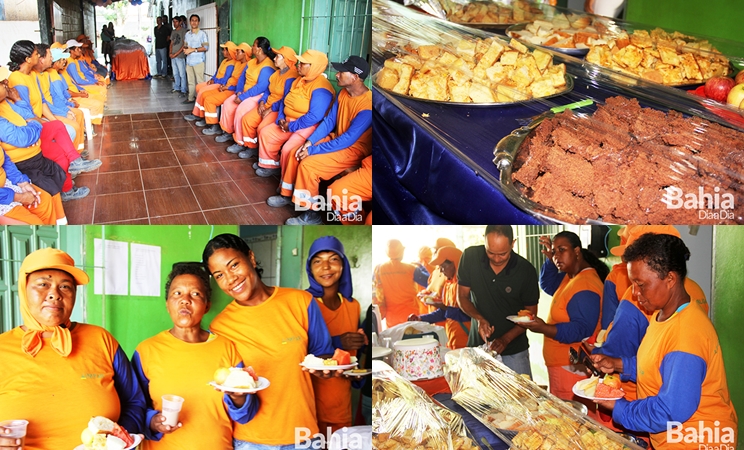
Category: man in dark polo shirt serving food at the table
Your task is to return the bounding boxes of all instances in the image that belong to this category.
[457,225,540,376]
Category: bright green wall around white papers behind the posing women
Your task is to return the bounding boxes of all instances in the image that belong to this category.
[80,225,238,357]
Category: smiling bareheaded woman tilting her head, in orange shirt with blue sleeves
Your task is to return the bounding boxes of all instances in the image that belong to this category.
[202,234,343,450]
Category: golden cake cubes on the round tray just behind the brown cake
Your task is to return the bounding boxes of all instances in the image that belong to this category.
[375,37,566,103]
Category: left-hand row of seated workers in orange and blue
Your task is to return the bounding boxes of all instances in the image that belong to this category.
[0,35,109,225]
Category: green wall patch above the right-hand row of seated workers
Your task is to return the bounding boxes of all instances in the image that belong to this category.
[230,0,302,51]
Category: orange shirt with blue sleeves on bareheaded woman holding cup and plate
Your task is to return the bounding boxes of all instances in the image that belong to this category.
[132,330,259,450]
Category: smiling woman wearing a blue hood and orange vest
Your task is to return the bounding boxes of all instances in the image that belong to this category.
[305,236,366,434]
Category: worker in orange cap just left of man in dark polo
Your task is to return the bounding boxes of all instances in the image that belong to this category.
[408,247,470,350]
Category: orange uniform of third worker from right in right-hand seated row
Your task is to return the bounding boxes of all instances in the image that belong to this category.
[235,67,298,148]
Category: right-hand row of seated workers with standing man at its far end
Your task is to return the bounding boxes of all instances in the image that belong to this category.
[179,33,372,225]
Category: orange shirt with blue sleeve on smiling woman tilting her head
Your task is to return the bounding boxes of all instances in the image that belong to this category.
[210,287,333,445]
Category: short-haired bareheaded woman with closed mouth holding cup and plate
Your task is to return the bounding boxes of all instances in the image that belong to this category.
[132,263,259,450]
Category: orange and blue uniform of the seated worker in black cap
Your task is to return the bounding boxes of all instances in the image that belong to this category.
[290,89,372,201]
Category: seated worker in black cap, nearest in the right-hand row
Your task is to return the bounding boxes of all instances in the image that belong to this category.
[268,55,372,224]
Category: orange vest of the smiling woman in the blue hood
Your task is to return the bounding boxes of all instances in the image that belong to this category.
[312,294,361,426]
